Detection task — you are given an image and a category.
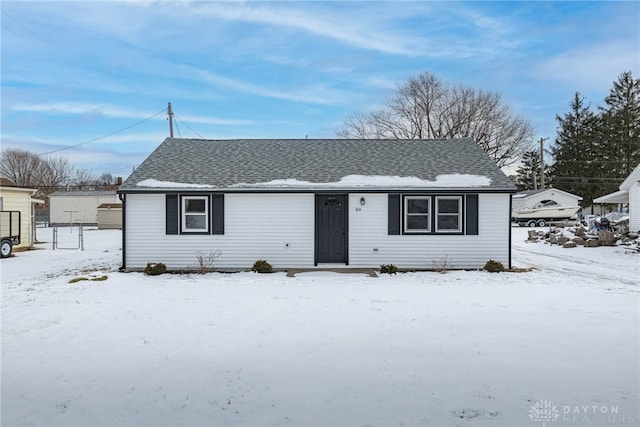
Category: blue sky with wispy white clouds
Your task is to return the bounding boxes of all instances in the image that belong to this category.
[0,1,640,177]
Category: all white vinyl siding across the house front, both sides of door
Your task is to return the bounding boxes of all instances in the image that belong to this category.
[126,193,510,270]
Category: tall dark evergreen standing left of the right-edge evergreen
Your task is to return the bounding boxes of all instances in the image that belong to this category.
[551,92,606,206]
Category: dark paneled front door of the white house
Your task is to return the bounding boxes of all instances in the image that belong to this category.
[316,194,347,264]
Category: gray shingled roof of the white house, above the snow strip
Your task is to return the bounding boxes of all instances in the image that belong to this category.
[120,138,515,192]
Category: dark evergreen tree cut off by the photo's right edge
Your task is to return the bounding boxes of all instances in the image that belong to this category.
[599,71,640,178]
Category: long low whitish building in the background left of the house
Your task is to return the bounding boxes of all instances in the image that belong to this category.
[49,191,120,225]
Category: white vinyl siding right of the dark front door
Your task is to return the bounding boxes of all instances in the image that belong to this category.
[349,193,511,269]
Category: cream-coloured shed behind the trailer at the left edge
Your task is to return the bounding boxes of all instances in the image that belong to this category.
[0,184,42,249]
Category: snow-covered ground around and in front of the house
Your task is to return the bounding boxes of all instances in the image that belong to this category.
[0,228,640,427]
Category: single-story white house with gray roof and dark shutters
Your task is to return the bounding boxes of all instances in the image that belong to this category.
[118,138,515,270]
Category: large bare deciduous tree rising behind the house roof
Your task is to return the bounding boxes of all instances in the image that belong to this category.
[337,72,535,167]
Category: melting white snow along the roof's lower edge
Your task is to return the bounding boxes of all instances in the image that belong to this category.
[137,174,491,188]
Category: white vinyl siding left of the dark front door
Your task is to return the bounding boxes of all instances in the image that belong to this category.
[125,194,315,270]
